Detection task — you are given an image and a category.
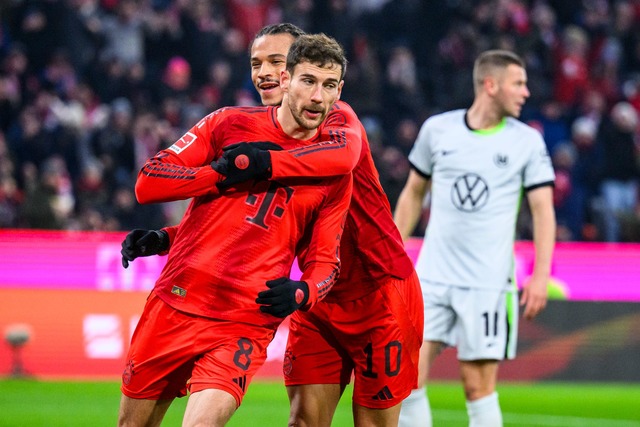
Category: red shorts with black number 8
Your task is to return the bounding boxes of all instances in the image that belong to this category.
[121,293,275,406]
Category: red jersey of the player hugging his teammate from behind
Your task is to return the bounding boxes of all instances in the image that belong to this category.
[271,101,413,301]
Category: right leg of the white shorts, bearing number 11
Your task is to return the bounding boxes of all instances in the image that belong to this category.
[452,288,518,360]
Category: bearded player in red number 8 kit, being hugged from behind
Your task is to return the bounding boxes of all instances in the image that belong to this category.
[119,35,352,426]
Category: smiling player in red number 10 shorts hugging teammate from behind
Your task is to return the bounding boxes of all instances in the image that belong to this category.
[122,24,423,426]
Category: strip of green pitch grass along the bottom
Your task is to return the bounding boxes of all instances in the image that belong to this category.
[0,379,640,427]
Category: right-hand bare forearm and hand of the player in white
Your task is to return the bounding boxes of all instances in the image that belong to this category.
[520,186,556,319]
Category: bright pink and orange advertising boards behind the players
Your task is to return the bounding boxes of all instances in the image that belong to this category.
[0,230,640,379]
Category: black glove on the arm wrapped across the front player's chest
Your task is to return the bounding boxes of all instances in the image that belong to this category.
[211,141,282,190]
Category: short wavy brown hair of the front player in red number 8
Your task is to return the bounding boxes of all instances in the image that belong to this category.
[287,33,347,80]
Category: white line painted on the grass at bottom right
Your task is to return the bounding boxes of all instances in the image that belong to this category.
[433,409,640,427]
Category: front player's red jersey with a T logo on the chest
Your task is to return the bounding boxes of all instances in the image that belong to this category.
[136,107,352,325]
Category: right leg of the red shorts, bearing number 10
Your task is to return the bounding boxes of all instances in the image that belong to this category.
[342,276,424,410]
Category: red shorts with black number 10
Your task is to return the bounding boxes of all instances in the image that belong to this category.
[283,273,424,409]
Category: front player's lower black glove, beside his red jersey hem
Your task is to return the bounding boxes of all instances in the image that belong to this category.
[256,277,309,317]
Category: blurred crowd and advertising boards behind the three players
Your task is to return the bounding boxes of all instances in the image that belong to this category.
[0,0,640,425]
